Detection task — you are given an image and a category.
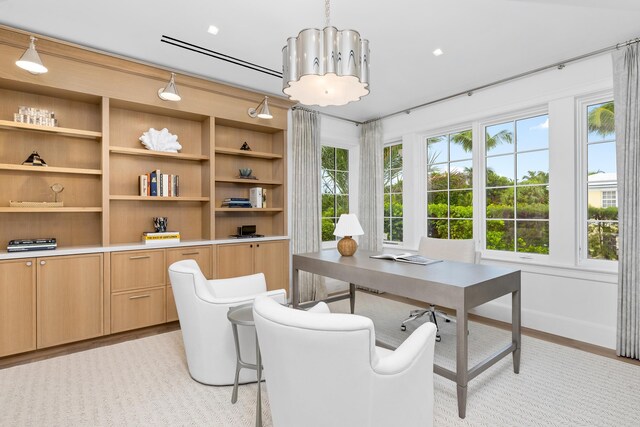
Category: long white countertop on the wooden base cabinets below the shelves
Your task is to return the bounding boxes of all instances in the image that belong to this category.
[0,236,289,260]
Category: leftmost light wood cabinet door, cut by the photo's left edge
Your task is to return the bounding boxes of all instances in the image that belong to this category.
[0,259,36,357]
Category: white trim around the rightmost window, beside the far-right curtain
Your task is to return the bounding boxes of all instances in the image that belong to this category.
[575,91,618,273]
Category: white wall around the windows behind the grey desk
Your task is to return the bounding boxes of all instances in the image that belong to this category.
[383,55,617,348]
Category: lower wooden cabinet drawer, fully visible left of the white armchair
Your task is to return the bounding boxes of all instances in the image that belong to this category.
[111,287,165,333]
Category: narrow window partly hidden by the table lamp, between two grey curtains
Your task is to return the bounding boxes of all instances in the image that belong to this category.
[321,146,349,242]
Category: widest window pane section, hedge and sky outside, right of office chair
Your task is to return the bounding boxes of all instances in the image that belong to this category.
[484,114,549,254]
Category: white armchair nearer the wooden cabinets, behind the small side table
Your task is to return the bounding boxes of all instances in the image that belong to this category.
[169,260,287,385]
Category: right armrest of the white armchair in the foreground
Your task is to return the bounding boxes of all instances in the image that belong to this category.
[372,322,436,375]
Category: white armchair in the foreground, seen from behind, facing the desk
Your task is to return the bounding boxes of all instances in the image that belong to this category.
[253,297,436,427]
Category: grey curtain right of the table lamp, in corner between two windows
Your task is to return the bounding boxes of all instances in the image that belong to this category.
[358,120,384,251]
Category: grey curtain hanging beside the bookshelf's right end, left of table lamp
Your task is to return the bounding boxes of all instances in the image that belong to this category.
[291,108,326,302]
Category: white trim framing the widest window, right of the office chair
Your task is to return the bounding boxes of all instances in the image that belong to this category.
[473,105,553,263]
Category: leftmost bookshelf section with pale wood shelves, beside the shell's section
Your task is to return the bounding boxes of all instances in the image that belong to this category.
[0,80,103,248]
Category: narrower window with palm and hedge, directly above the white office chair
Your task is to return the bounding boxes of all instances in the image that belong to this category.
[427,130,473,239]
